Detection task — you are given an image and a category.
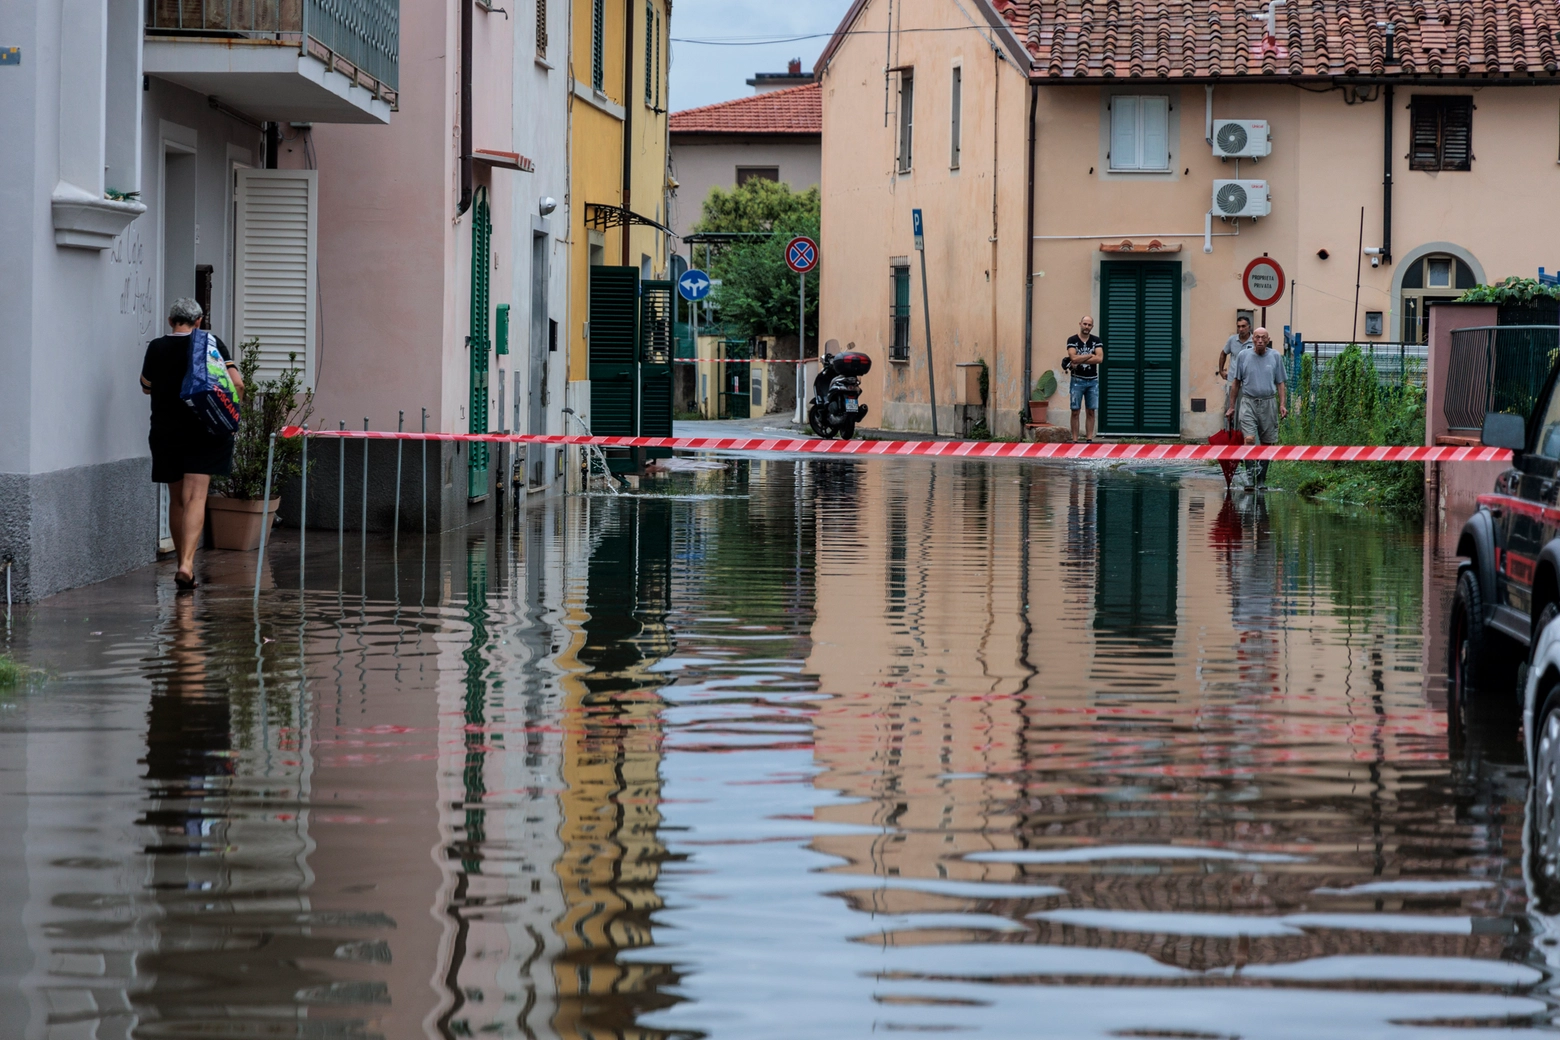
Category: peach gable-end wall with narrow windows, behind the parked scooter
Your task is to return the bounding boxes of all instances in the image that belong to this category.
[819,0,1028,435]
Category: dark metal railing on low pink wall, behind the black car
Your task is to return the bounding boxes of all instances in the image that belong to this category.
[1441,324,1560,430]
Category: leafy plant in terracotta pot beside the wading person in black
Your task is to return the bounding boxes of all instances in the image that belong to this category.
[206,338,314,550]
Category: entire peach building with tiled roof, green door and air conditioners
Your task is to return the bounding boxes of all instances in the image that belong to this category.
[816,0,1560,437]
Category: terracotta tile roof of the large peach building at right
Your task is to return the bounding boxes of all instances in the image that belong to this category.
[985,0,1560,77]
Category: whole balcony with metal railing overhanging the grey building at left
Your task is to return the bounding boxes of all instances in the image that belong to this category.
[144,0,401,123]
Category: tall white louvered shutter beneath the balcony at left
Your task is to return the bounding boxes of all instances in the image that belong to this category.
[232,170,320,387]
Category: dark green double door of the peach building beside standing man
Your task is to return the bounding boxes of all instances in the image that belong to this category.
[1100,260,1181,437]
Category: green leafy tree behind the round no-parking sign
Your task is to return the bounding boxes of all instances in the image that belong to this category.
[694,178,819,343]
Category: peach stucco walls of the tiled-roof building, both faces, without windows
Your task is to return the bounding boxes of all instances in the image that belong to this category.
[822,3,1560,437]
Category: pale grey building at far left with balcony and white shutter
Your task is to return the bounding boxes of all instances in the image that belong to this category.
[0,0,399,599]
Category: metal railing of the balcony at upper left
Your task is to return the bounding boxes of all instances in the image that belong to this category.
[147,0,401,92]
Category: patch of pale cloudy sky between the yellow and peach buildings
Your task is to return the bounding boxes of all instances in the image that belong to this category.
[671,0,850,112]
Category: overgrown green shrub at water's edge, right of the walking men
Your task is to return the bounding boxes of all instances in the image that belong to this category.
[1268,343,1424,516]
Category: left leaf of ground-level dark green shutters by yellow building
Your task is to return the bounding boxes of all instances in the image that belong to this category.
[590,265,640,437]
